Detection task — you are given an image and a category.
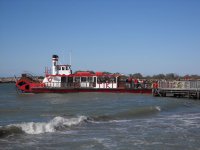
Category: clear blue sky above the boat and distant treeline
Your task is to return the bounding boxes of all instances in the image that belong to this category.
[0,0,200,77]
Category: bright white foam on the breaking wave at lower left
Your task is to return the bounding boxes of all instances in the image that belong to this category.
[9,116,87,134]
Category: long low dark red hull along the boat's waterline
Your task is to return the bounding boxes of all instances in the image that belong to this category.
[31,88,152,94]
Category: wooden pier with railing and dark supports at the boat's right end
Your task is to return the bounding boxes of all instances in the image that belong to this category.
[152,80,200,99]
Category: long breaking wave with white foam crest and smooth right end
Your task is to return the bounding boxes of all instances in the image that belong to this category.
[0,106,161,138]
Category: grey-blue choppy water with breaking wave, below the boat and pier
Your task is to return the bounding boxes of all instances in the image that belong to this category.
[0,84,200,150]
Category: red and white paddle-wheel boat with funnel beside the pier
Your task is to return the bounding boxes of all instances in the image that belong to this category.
[16,55,152,94]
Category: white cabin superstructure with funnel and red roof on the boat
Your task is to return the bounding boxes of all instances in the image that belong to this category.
[43,55,119,89]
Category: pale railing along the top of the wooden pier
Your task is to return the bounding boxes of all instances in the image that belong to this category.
[158,80,200,90]
